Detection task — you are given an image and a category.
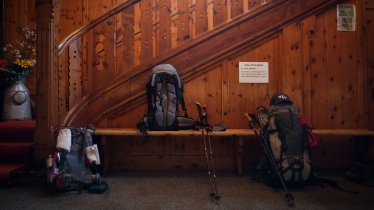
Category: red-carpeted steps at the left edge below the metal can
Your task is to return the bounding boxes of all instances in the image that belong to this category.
[0,120,36,186]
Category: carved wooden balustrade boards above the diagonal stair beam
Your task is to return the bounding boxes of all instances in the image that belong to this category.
[59,0,268,108]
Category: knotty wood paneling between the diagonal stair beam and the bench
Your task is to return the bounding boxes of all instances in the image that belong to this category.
[107,1,370,128]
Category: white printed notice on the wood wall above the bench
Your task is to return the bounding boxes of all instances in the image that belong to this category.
[239,62,269,83]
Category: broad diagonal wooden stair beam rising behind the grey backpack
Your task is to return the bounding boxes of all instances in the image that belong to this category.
[63,0,338,125]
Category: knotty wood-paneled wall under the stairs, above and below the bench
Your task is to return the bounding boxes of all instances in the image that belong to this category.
[108,1,374,170]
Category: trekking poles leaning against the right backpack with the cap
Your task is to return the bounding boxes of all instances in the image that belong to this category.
[244,113,294,206]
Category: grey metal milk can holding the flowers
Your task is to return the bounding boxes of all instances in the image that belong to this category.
[2,81,32,121]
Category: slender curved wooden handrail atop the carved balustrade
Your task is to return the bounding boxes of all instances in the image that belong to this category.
[57,0,140,55]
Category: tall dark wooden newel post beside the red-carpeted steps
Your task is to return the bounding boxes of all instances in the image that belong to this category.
[33,0,59,163]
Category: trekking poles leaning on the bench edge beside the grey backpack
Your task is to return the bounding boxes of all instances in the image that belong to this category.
[196,102,221,204]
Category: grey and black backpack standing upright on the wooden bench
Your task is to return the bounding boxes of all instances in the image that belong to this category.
[137,64,195,131]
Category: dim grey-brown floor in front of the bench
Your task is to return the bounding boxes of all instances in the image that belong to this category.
[0,171,374,210]
